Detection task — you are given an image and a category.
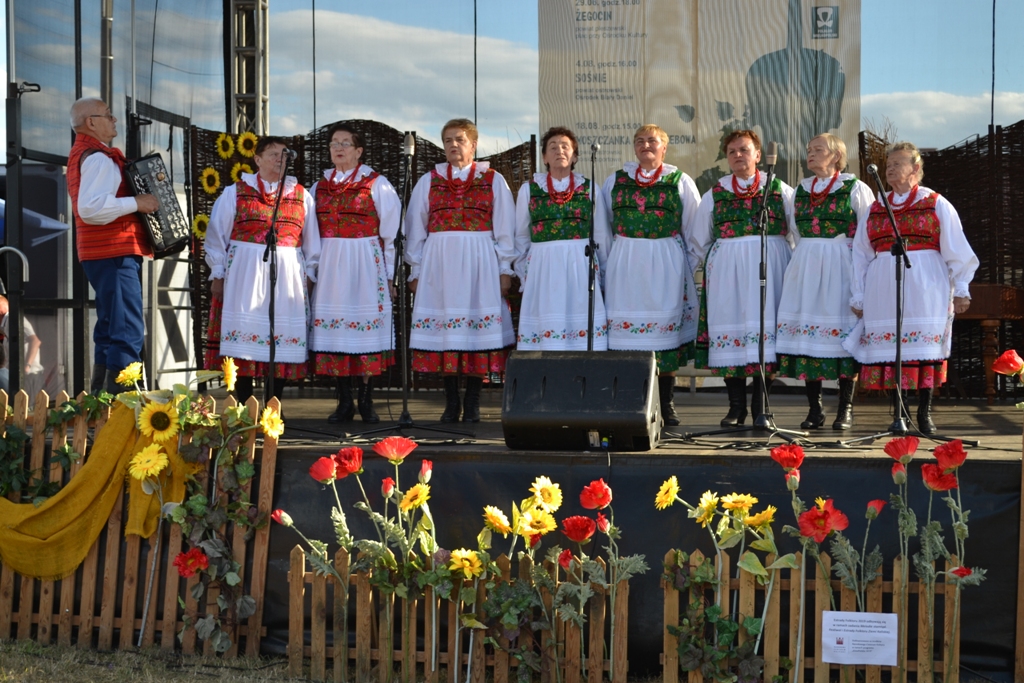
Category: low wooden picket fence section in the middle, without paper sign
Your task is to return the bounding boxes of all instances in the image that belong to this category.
[288,546,629,683]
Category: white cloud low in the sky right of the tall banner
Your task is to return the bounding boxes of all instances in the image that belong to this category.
[860,91,1024,148]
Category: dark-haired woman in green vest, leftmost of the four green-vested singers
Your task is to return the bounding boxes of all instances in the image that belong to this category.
[515,127,611,351]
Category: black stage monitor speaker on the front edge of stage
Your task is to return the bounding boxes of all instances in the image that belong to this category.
[502,351,662,451]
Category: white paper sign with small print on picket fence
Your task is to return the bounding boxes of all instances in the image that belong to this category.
[821,611,897,667]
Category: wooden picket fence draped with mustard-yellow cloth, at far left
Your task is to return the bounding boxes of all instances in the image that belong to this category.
[0,391,280,656]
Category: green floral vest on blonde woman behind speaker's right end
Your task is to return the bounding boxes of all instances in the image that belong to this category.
[611,169,683,240]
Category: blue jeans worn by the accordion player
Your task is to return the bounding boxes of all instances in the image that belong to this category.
[82,256,145,373]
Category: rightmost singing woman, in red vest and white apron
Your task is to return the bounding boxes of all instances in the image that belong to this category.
[844,142,978,434]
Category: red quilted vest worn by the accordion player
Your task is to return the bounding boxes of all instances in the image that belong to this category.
[68,133,153,261]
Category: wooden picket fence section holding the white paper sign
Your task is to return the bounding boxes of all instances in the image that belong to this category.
[662,551,961,683]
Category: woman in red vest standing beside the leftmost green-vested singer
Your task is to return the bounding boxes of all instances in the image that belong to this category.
[406,119,515,422]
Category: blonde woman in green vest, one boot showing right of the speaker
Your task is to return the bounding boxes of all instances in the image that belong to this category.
[597,124,700,425]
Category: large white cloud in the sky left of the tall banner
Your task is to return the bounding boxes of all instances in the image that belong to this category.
[270,10,540,156]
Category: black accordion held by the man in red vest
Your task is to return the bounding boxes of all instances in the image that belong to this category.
[125,154,190,258]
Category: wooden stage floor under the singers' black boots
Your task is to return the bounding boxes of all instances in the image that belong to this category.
[249,387,1024,460]
